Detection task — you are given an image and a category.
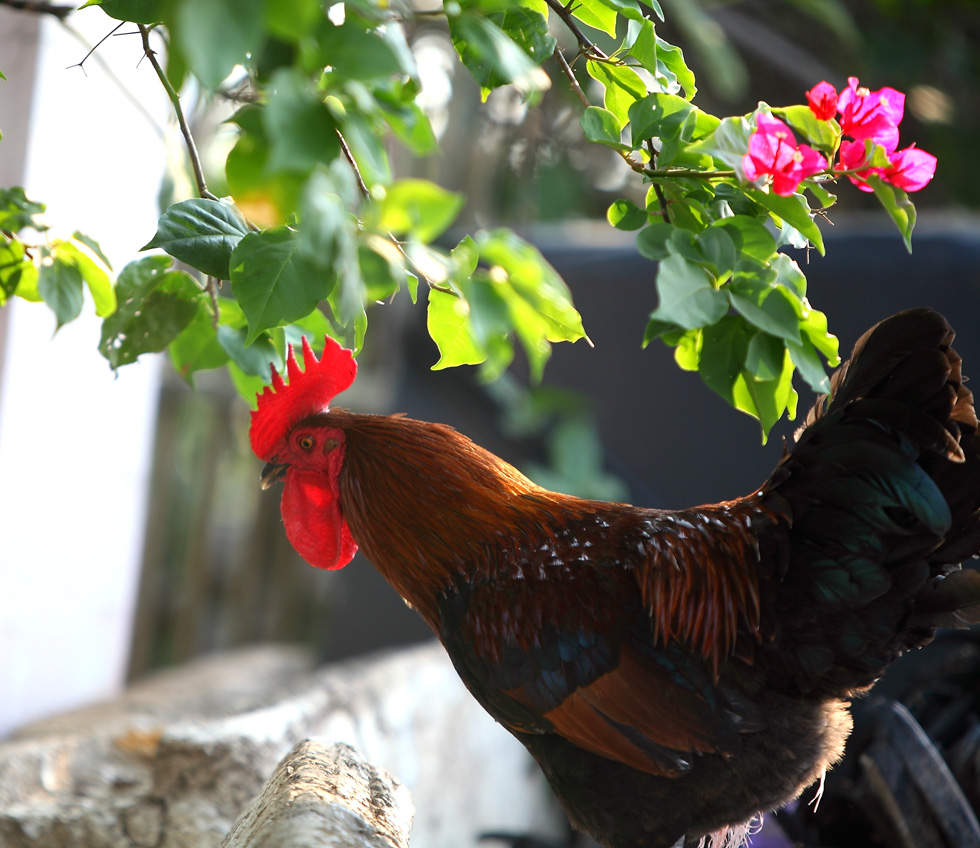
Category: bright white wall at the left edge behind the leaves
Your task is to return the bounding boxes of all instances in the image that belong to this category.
[0,7,168,736]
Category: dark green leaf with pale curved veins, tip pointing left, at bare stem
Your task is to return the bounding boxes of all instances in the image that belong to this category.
[141,198,255,280]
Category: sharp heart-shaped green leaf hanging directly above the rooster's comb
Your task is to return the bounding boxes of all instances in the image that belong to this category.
[231,226,333,344]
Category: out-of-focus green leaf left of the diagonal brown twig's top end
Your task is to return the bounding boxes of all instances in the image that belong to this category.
[262,68,340,173]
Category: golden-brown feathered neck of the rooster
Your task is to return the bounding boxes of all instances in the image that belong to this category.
[331,410,545,628]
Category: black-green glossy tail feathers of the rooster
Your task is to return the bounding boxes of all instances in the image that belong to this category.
[770,309,980,688]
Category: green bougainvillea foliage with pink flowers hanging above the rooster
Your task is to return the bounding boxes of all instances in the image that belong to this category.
[0,0,927,434]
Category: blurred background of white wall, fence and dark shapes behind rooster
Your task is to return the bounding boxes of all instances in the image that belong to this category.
[0,0,980,736]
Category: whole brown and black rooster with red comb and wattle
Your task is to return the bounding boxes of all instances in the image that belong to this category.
[250,309,980,848]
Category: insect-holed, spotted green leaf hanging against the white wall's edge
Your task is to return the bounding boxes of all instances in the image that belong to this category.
[99,256,205,370]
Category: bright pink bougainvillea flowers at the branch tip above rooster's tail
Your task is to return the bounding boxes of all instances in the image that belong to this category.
[743,77,936,196]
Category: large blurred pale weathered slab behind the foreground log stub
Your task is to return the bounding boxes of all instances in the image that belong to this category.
[0,643,557,848]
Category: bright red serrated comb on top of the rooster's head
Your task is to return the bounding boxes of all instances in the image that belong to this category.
[249,336,357,461]
